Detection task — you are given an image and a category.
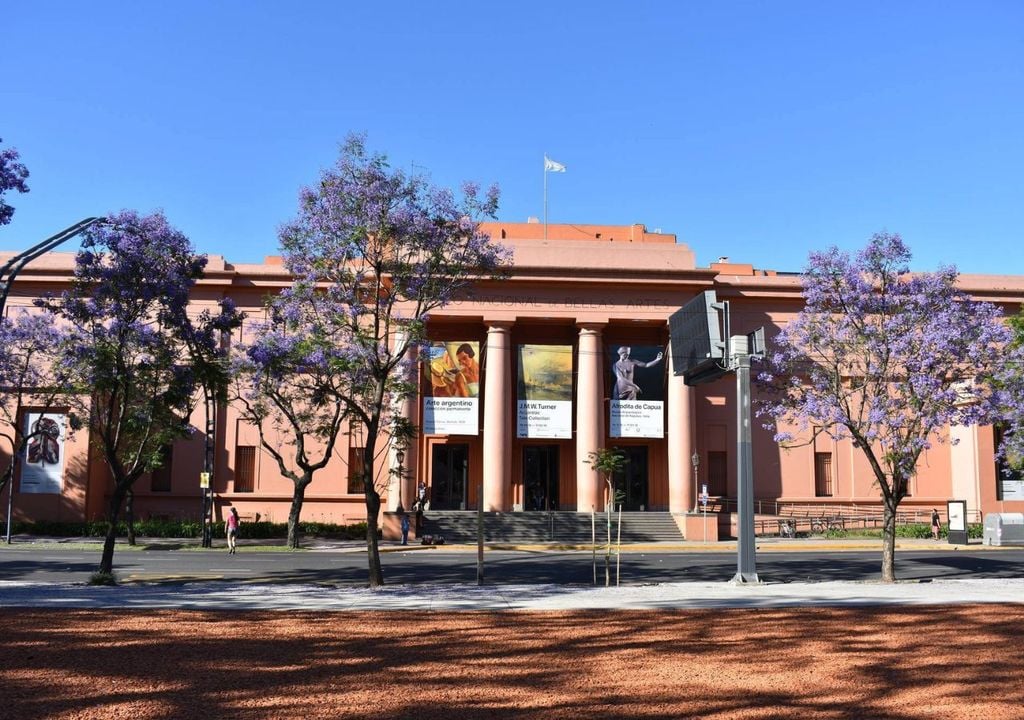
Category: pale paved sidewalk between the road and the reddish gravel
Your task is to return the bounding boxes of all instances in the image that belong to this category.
[0,579,1024,611]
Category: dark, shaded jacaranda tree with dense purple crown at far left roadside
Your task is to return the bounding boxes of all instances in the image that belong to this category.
[41,211,238,577]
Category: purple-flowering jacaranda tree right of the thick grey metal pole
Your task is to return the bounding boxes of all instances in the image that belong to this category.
[760,234,1022,582]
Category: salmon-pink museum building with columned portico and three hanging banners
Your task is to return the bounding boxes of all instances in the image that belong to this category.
[7,222,1024,536]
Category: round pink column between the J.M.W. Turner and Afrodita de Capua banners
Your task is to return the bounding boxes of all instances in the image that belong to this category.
[575,323,604,512]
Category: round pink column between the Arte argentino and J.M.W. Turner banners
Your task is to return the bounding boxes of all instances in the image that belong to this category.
[483,322,512,511]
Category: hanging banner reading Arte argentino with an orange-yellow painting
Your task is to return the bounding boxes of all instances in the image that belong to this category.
[423,340,480,435]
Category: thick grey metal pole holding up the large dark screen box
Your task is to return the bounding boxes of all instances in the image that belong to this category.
[732,335,760,583]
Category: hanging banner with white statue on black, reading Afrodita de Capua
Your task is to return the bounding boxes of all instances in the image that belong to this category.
[608,345,666,437]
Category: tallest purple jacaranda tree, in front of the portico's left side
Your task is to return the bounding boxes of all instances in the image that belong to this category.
[240,136,508,587]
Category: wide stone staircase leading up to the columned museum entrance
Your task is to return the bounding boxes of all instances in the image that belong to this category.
[421,510,682,545]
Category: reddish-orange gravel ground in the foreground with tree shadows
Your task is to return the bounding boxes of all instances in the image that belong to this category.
[0,605,1024,720]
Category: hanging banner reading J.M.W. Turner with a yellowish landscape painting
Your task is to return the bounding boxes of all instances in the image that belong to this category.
[516,345,572,437]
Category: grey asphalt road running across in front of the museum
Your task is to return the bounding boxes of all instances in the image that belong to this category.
[0,547,1024,585]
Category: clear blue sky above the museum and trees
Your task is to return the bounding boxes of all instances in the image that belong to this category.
[0,0,1024,273]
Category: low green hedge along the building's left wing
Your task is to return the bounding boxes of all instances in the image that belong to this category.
[4,519,367,540]
